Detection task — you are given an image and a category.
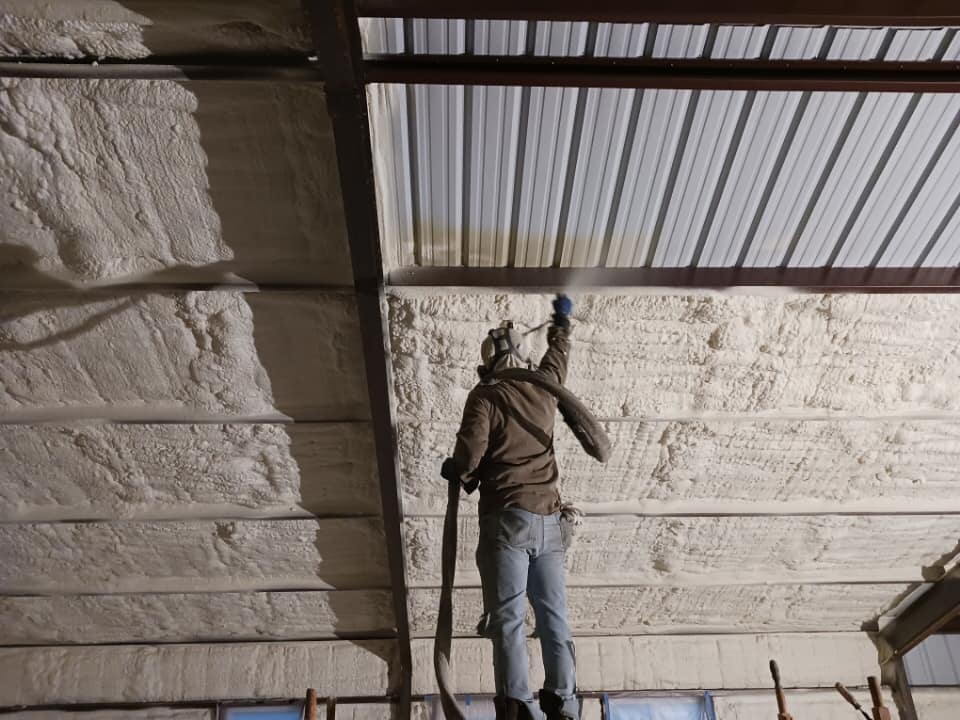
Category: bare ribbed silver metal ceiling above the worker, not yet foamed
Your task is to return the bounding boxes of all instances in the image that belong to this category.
[364,19,960,267]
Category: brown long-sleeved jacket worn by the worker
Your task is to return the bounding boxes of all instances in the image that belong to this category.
[453,326,570,515]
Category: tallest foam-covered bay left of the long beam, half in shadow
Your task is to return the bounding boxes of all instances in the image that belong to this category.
[0,79,351,288]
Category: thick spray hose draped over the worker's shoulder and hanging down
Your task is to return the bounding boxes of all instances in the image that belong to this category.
[433,368,611,720]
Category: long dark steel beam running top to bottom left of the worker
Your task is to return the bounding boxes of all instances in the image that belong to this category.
[303,0,413,720]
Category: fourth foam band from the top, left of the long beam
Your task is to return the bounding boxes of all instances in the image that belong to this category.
[0,423,380,522]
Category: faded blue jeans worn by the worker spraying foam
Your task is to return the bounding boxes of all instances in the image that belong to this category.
[477,508,580,720]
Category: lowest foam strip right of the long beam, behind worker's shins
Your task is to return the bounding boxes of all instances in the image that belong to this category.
[413,633,878,694]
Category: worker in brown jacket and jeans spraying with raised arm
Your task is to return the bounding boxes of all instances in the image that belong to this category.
[441,295,580,720]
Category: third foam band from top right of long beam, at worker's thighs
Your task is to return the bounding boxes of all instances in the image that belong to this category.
[406,515,960,587]
